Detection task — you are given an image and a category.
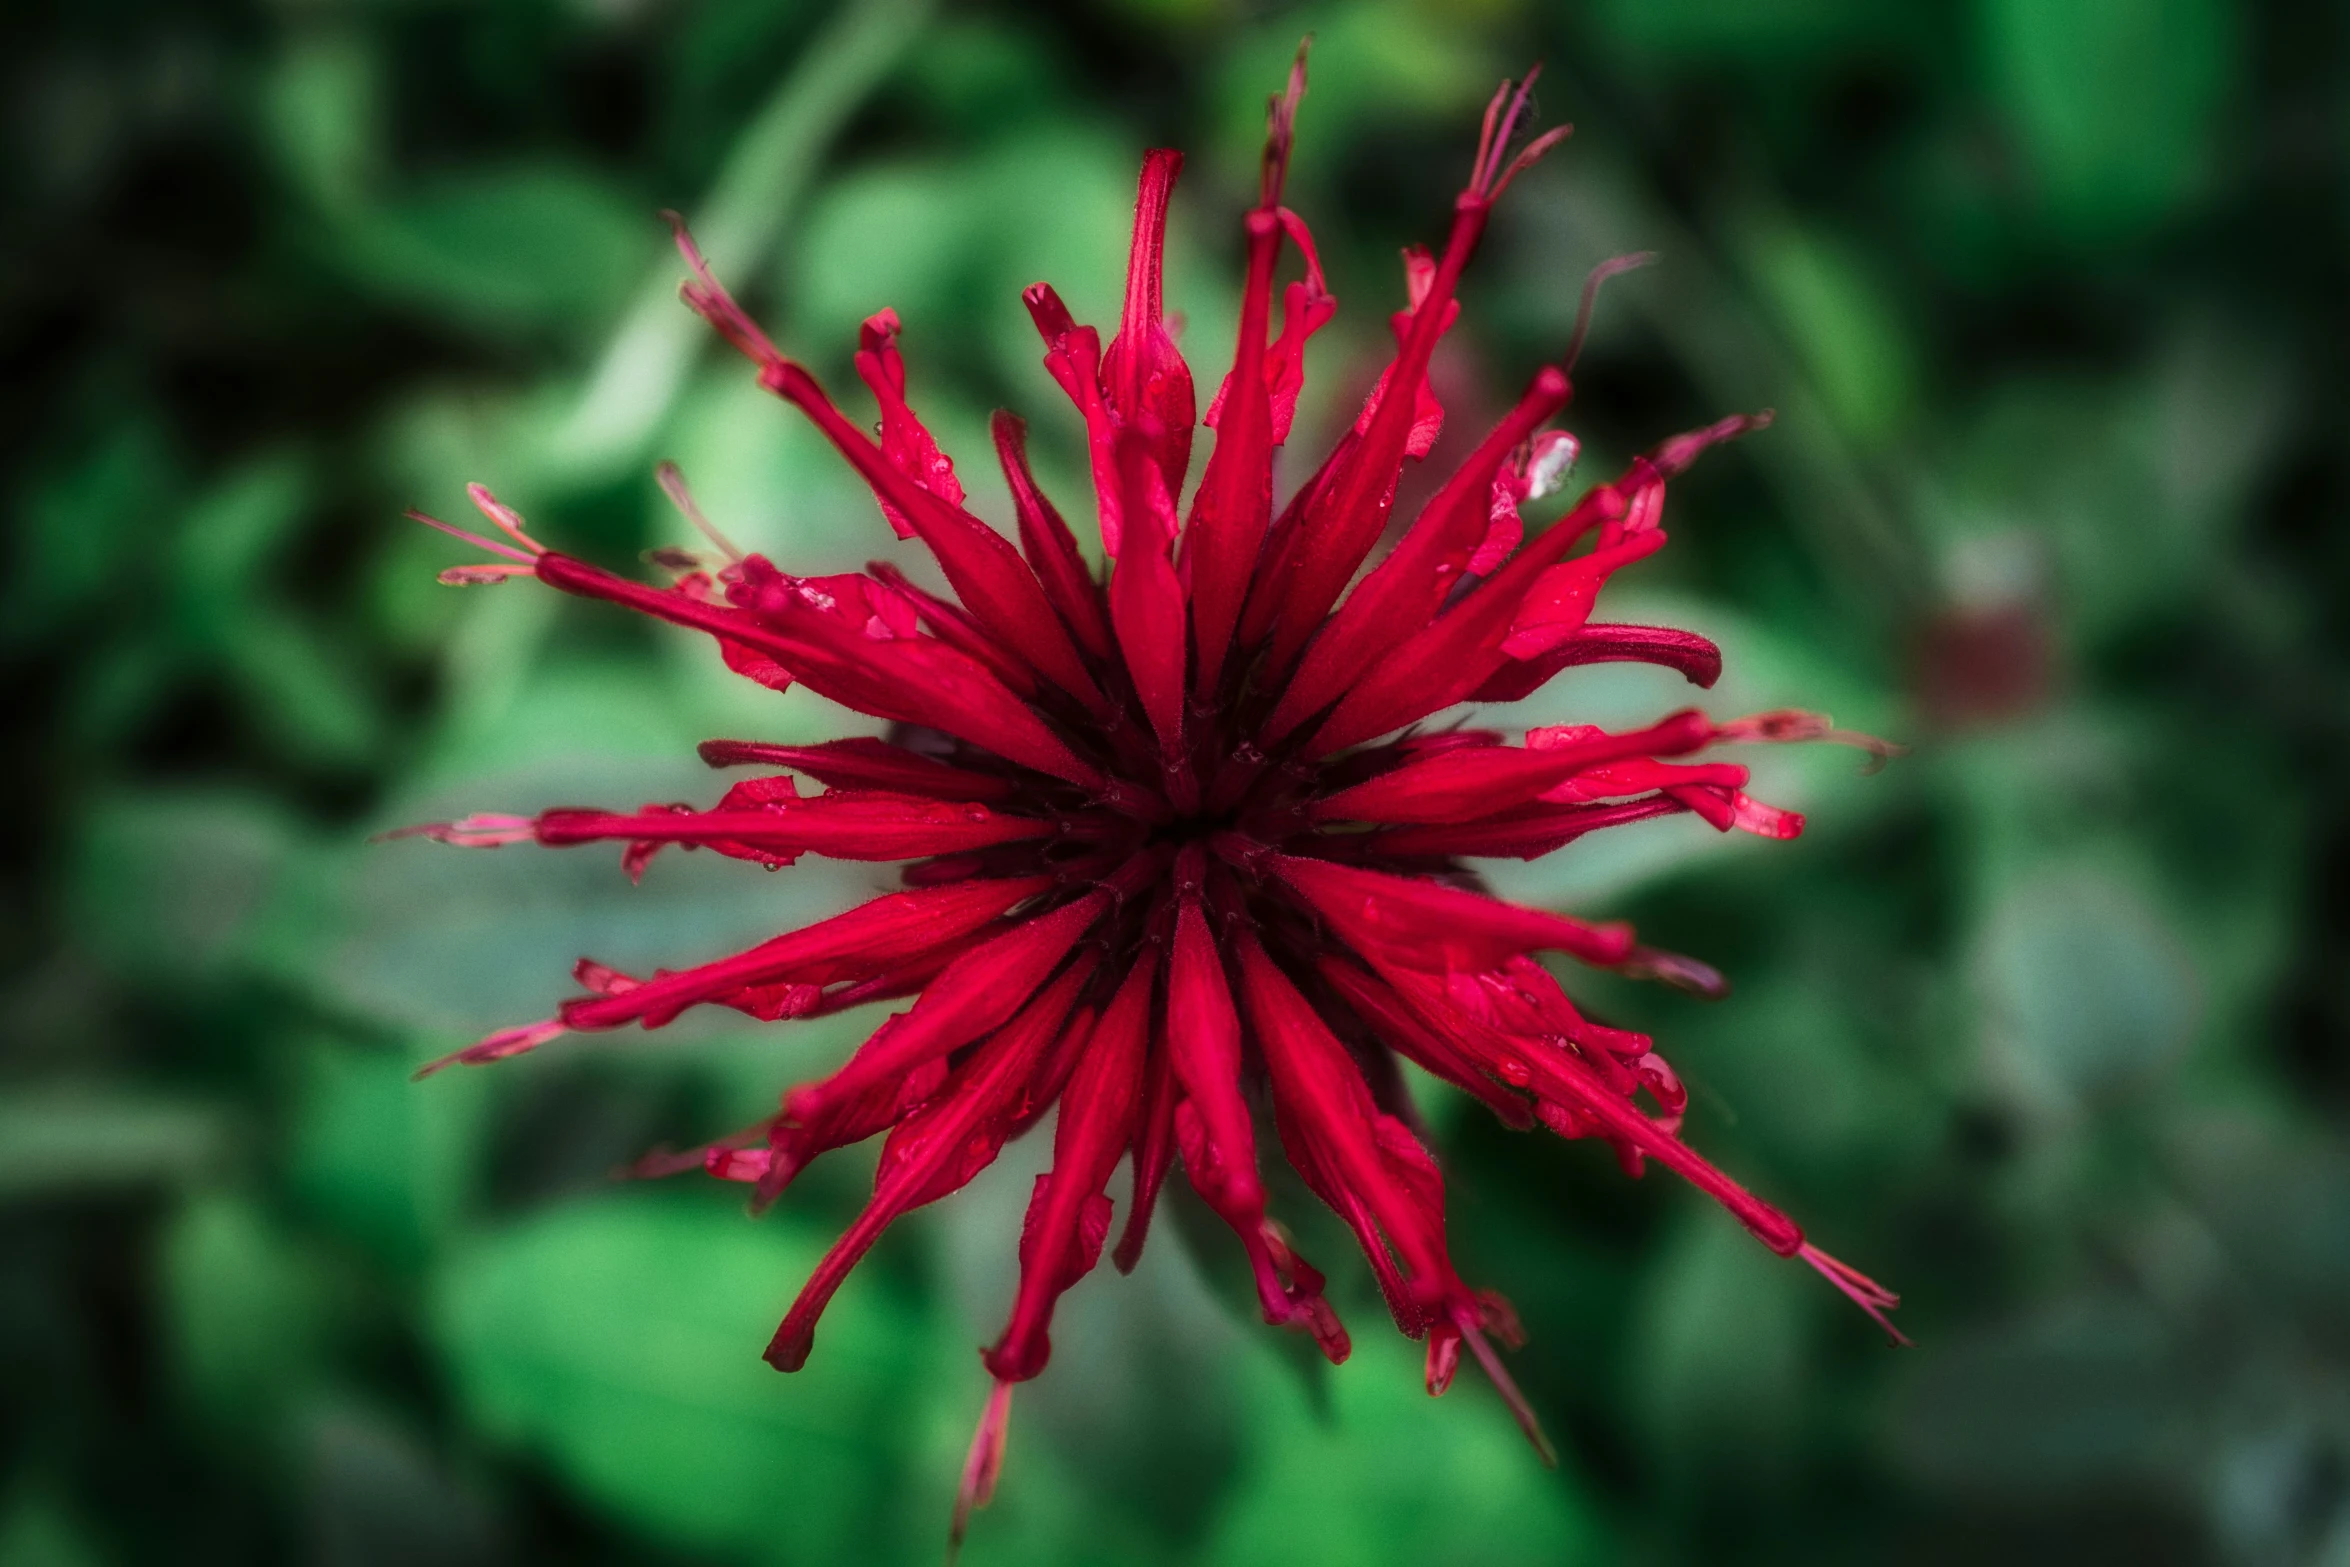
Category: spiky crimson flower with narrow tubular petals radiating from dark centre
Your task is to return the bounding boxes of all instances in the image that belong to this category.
[418,63,1899,1532]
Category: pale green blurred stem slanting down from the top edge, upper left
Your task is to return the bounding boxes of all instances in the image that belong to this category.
[548,0,933,479]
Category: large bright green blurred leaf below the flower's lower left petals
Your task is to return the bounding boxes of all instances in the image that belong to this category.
[432,1196,921,1562]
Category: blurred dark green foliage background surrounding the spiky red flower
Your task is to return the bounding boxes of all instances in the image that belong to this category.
[0,0,2350,1567]
